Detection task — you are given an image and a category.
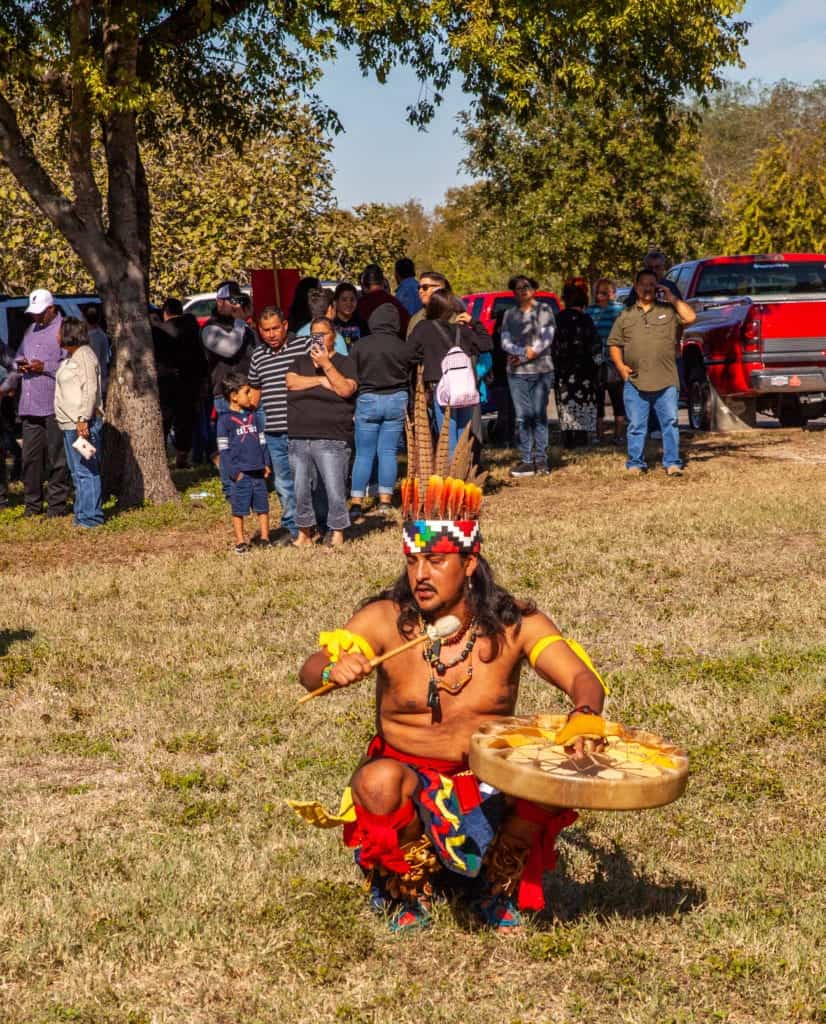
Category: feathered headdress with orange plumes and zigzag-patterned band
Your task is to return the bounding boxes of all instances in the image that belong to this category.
[401,368,487,555]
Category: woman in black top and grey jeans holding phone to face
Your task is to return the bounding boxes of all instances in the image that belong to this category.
[287,316,358,548]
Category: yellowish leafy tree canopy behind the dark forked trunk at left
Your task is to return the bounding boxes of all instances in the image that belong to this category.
[0,99,333,302]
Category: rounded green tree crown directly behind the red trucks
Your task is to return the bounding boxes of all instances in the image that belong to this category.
[465,95,711,280]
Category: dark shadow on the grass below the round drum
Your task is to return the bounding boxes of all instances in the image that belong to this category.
[538,830,706,923]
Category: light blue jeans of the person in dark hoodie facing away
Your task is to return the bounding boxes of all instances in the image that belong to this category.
[350,391,407,498]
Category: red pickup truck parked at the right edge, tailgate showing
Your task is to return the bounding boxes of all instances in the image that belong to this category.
[667,253,826,430]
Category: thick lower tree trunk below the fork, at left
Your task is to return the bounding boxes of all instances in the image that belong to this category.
[98,261,178,509]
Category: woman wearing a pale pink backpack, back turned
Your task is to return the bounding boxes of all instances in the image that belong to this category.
[408,288,492,455]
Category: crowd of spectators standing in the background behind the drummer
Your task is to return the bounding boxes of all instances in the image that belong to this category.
[0,253,693,553]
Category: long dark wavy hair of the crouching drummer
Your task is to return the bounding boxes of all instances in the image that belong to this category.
[358,555,536,660]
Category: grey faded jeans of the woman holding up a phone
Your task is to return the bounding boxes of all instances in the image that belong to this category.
[290,437,350,529]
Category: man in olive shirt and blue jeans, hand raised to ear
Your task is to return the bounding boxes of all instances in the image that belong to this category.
[608,270,697,476]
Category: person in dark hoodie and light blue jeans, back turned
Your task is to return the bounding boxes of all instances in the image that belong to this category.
[350,302,414,520]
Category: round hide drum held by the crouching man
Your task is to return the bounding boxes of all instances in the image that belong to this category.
[470,715,688,811]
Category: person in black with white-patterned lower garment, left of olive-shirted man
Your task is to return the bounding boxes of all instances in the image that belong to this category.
[551,285,602,449]
